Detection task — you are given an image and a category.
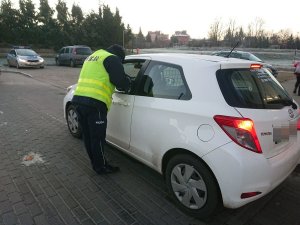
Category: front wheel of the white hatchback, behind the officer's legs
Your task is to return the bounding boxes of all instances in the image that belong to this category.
[66,105,82,138]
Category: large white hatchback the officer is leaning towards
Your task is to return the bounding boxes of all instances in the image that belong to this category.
[64,53,300,218]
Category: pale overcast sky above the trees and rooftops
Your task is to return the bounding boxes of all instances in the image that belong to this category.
[11,0,300,38]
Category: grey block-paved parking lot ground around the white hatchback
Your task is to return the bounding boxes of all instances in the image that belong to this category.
[0,66,300,225]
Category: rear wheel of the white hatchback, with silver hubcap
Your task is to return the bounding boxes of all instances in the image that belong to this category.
[165,154,220,219]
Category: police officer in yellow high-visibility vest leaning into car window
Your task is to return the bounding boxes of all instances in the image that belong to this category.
[72,44,131,174]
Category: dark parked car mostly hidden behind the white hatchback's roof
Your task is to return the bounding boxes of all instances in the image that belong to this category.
[212,50,278,77]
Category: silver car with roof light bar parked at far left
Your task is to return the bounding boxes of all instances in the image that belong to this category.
[6,47,44,69]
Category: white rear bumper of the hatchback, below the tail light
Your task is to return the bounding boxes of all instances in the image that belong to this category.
[203,139,300,208]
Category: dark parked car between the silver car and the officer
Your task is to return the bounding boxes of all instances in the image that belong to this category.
[55,45,92,67]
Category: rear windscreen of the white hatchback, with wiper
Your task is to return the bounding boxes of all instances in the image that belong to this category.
[217,68,292,109]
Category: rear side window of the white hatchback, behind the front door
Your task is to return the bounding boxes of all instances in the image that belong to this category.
[137,62,191,100]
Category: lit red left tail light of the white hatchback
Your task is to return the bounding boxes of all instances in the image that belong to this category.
[214,115,262,153]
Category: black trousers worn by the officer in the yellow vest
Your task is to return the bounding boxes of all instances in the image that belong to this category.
[76,105,107,170]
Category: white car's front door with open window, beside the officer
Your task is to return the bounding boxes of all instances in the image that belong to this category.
[106,60,145,151]
